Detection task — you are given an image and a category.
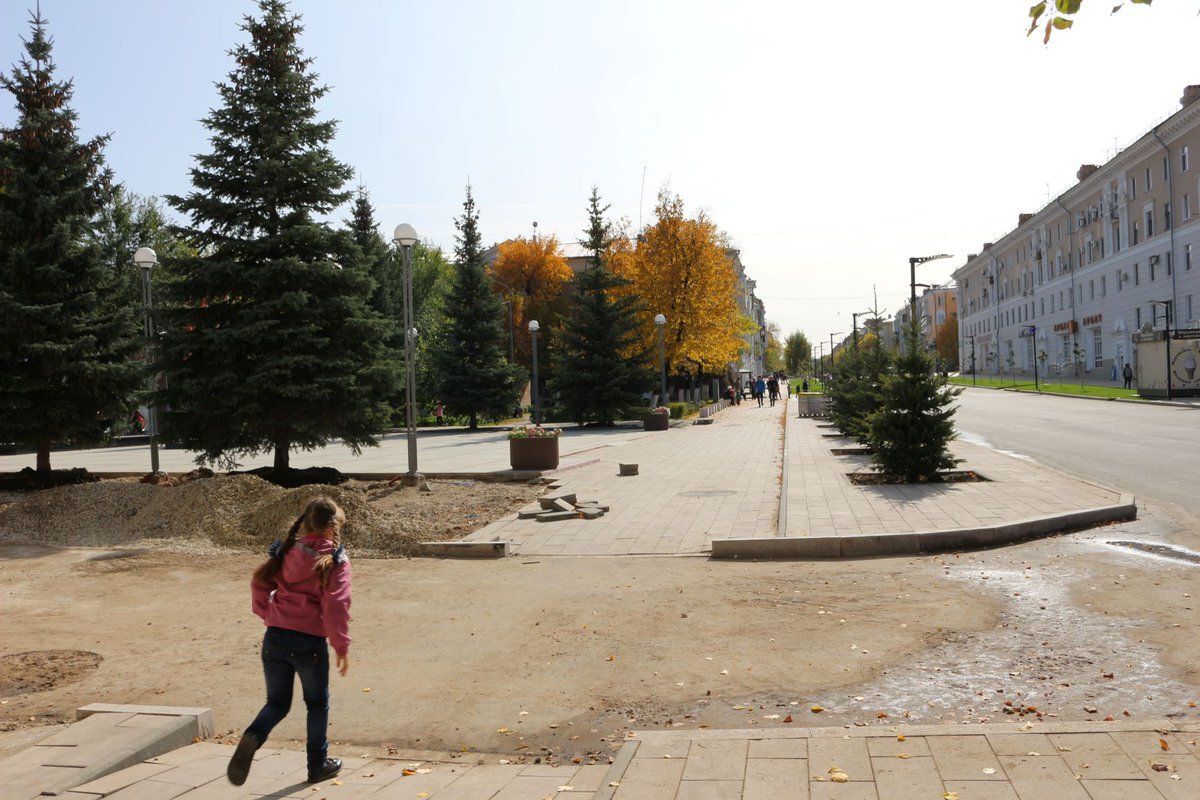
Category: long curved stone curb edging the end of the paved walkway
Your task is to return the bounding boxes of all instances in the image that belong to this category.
[710,494,1138,559]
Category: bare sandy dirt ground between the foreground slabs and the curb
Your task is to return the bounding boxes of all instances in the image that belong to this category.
[0,482,1200,763]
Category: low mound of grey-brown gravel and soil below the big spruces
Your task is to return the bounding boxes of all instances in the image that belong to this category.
[0,475,541,558]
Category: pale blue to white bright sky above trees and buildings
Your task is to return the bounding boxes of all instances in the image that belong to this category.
[0,0,1200,343]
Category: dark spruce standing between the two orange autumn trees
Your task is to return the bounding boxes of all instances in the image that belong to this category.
[552,186,653,426]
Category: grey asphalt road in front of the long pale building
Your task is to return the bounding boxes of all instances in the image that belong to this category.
[955,387,1200,518]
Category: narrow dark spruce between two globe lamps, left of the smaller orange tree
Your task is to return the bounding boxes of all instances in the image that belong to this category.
[433,185,522,431]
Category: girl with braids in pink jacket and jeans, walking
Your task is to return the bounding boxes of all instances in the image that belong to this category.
[227,498,350,786]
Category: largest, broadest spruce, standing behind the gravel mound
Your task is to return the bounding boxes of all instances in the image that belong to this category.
[164,0,397,469]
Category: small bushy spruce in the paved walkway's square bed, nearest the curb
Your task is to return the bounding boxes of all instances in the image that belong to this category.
[868,314,962,483]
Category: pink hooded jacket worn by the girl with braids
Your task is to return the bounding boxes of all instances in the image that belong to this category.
[250,536,350,656]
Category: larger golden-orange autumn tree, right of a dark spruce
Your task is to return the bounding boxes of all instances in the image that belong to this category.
[608,190,754,375]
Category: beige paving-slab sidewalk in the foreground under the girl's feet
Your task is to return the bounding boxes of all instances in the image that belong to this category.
[21,720,1200,800]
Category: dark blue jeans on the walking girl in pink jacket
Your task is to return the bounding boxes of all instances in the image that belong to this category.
[246,627,329,769]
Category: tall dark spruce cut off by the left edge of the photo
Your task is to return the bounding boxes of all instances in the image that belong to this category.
[0,16,143,471]
